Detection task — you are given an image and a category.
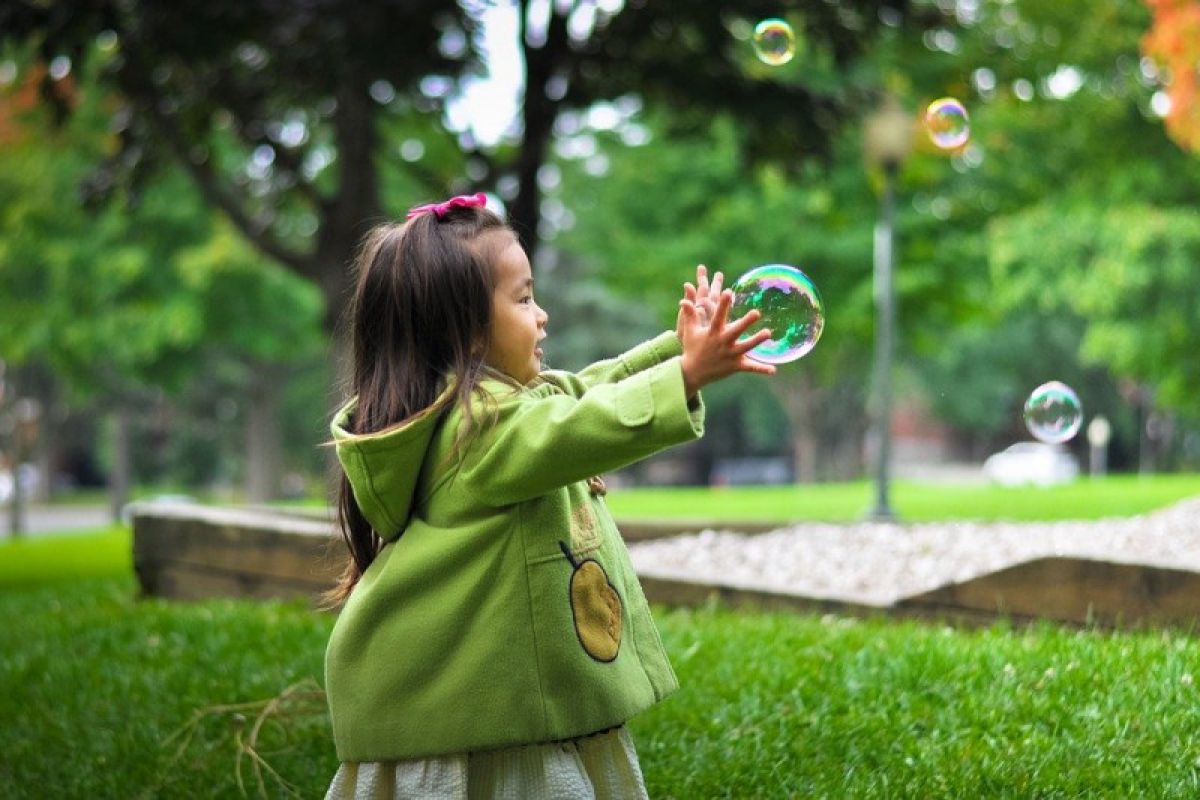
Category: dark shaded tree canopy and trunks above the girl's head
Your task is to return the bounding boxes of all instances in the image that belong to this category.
[0,0,906,343]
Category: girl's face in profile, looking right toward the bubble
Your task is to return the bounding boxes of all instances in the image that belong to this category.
[484,239,548,384]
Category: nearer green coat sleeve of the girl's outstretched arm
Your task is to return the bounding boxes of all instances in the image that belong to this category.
[458,356,704,506]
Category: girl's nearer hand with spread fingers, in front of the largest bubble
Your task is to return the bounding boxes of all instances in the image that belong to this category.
[676,287,775,401]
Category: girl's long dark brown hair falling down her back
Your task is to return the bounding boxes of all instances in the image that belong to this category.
[325,207,514,606]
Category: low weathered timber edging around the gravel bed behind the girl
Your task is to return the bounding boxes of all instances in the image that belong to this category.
[132,504,1200,628]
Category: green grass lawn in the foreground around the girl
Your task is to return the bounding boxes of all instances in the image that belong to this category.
[0,576,1200,800]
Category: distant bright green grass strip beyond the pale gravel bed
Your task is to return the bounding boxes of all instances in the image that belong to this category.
[605,474,1200,522]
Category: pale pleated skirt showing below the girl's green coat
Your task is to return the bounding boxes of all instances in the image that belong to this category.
[325,726,647,800]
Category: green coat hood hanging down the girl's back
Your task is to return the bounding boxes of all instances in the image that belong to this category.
[329,397,446,541]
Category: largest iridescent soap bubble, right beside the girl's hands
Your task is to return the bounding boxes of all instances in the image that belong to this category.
[730,264,824,363]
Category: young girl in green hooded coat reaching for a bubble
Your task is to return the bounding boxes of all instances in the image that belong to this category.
[325,194,774,799]
